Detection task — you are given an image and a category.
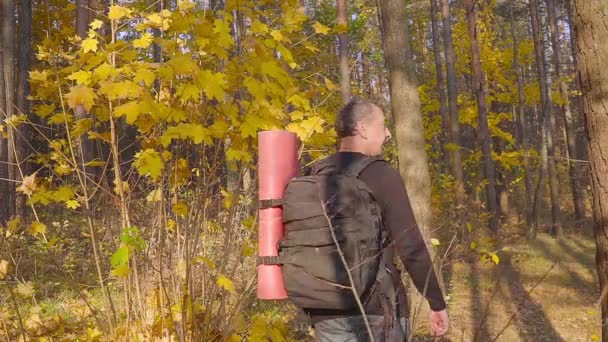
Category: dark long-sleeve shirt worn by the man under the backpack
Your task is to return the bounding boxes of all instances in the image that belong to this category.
[308,152,446,324]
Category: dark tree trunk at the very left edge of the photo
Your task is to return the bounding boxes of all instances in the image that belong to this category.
[2,0,17,216]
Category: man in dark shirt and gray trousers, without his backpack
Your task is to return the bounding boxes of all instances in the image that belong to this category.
[306,98,448,342]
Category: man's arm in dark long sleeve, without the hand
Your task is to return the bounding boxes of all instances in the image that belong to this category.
[360,162,446,311]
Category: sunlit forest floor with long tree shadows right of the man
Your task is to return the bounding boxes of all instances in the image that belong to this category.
[414,226,600,342]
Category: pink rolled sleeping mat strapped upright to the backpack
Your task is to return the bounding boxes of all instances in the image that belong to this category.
[257,131,299,300]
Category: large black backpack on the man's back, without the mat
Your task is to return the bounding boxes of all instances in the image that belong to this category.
[262,156,383,310]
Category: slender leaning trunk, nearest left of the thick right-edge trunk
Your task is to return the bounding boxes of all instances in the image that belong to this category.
[546,0,585,222]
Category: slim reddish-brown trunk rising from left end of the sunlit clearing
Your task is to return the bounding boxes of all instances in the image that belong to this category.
[464,0,498,231]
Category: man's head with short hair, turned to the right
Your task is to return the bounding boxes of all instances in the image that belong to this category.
[335,98,391,156]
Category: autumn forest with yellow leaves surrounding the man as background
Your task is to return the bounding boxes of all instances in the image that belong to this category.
[0,0,608,342]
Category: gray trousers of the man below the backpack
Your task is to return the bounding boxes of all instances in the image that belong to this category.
[314,315,408,342]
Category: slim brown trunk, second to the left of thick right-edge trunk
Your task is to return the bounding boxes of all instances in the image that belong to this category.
[529,0,562,237]
